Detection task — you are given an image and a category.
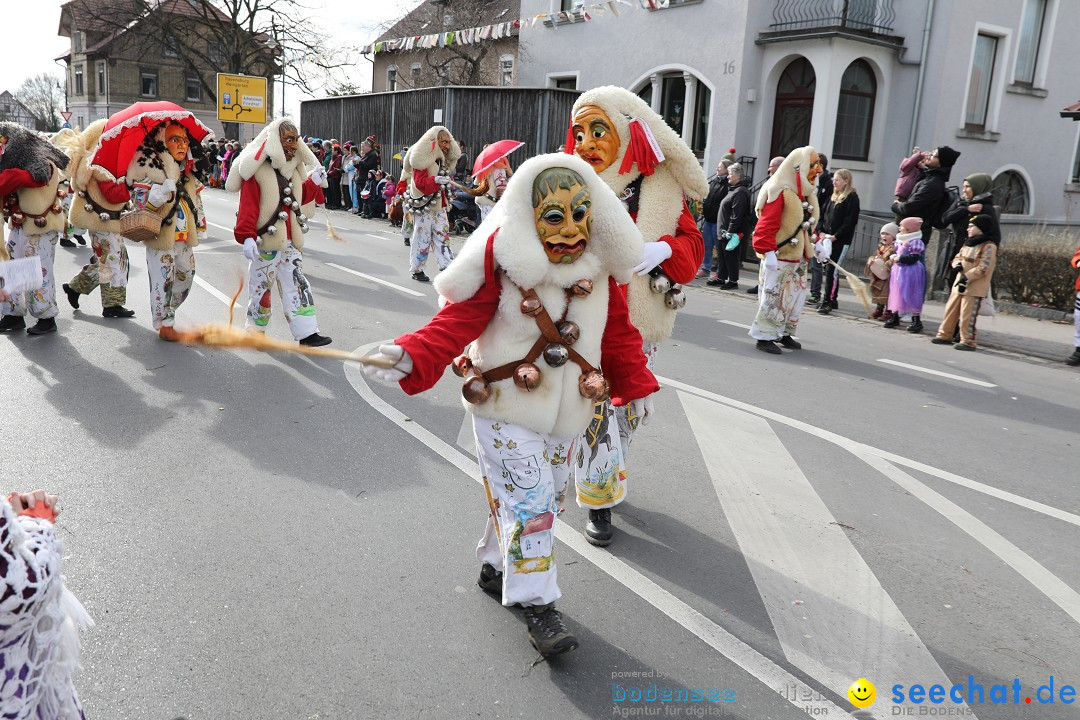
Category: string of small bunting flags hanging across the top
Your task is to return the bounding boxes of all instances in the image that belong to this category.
[361,0,671,55]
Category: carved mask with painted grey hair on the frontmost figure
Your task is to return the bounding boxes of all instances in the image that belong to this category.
[532,167,593,263]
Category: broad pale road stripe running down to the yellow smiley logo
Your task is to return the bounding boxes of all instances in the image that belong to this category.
[678,392,967,718]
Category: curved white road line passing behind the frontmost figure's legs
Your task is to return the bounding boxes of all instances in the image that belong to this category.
[345,342,850,717]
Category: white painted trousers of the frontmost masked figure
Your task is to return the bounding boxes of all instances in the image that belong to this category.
[473,416,570,606]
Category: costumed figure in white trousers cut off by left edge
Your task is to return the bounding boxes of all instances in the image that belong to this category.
[0,122,69,335]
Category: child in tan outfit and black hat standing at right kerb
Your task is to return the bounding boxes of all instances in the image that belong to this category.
[931,213,1001,352]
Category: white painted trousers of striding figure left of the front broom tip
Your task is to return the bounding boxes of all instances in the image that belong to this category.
[247,243,319,340]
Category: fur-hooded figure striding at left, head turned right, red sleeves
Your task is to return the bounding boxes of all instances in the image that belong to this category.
[225,118,330,347]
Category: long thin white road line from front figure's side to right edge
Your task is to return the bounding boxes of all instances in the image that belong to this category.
[657,376,1080,527]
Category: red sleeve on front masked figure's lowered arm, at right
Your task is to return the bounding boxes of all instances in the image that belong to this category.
[600,278,656,406]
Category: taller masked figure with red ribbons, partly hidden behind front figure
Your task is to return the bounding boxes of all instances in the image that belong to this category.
[566,86,708,545]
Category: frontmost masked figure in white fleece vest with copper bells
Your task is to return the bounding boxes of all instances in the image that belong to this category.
[365,153,658,655]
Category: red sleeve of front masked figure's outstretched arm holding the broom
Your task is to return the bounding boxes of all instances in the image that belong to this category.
[394,281,502,395]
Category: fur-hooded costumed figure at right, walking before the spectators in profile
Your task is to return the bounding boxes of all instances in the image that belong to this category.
[750,146,832,355]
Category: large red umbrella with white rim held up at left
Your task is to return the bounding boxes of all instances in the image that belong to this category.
[91,100,210,179]
